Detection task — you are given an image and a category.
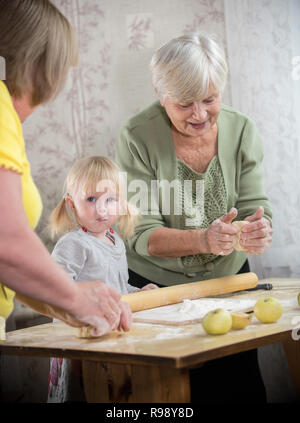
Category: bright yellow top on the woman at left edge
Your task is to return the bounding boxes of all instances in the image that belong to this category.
[0,81,42,319]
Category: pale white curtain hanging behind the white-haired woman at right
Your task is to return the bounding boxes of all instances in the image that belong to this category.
[224,0,300,277]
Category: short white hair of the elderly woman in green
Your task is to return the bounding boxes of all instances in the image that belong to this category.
[150,32,228,103]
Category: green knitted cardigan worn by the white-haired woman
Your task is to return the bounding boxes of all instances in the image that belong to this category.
[116,102,272,285]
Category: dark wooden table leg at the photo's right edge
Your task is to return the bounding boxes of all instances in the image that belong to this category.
[282,334,300,401]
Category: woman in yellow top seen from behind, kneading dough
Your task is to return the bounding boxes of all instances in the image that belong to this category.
[0,0,131,336]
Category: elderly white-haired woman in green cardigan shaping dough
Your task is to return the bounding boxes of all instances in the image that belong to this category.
[117,33,273,404]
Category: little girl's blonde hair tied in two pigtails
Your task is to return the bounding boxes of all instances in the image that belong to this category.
[50,156,139,239]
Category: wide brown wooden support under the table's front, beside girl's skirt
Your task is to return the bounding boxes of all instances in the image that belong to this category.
[82,361,190,403]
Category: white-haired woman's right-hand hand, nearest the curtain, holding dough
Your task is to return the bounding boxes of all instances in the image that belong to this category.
[240,207,274,254]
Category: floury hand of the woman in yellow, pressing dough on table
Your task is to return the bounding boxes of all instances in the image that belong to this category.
[71,281,131,336]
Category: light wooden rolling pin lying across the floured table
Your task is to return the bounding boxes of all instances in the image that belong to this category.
[122,272,258,312]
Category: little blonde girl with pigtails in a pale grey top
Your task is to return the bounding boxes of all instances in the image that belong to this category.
[48,156,156,402]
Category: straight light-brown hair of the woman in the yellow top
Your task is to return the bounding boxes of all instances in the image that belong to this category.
[0,0,78,106]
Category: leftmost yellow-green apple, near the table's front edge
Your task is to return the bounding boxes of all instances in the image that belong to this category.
[202,308,232,335]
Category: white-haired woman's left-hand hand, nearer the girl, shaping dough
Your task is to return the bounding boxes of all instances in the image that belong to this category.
[205,207,238,256]
